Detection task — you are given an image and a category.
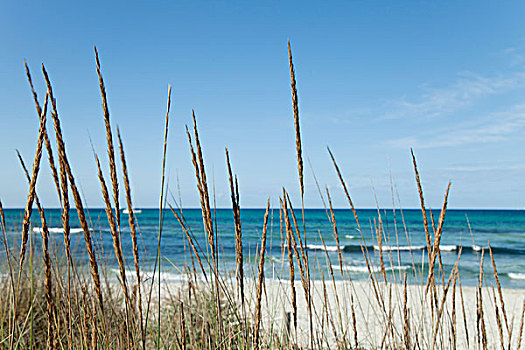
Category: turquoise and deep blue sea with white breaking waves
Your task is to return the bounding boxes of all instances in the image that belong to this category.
[1,209,525,289]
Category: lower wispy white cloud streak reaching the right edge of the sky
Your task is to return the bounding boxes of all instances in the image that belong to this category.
[387,104,525,148]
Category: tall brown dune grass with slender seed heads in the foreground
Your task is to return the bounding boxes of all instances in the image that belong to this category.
[0,43,525,349]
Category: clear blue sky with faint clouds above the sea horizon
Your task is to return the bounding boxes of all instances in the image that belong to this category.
[0,0,525,209]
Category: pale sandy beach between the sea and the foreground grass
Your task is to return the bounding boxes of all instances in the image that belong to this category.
[152,279,525,349]
